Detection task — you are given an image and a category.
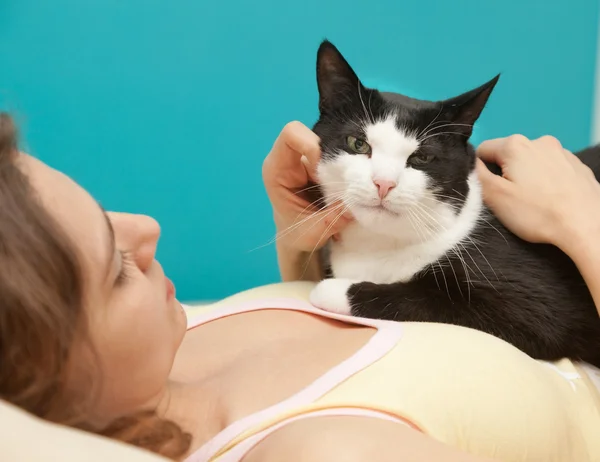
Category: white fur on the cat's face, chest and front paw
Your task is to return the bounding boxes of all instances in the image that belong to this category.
[315,117,483,286]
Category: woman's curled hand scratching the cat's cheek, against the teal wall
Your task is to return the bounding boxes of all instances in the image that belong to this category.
[262,122,351,252]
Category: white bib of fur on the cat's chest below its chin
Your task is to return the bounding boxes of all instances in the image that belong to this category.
[330,177,483,284]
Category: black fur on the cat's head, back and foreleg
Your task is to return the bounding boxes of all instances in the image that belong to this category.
[314,38,600,366]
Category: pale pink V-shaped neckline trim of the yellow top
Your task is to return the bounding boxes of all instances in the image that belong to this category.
[186,298,402,462]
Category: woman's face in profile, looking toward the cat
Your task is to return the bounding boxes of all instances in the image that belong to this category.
[19,155,186,420]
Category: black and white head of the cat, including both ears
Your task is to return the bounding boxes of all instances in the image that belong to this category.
[314,41,499,237]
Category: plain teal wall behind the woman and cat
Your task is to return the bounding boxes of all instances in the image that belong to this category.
[0,0,598,299]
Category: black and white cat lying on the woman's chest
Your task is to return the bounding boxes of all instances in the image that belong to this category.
[310,41,600,366]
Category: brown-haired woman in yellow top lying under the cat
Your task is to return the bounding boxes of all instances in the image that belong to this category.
[0,116,600,462]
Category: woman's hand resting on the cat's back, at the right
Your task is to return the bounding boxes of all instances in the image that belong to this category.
[477,135,600,253]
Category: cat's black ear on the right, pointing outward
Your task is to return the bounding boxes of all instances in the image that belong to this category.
[442,74,500,137]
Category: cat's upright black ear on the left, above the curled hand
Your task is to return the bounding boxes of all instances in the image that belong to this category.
[317,40,365,112]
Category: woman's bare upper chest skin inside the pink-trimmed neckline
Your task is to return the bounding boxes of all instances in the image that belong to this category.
[172,310,375,423]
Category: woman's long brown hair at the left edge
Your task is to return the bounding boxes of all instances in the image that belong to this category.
[0,113,191,459]
